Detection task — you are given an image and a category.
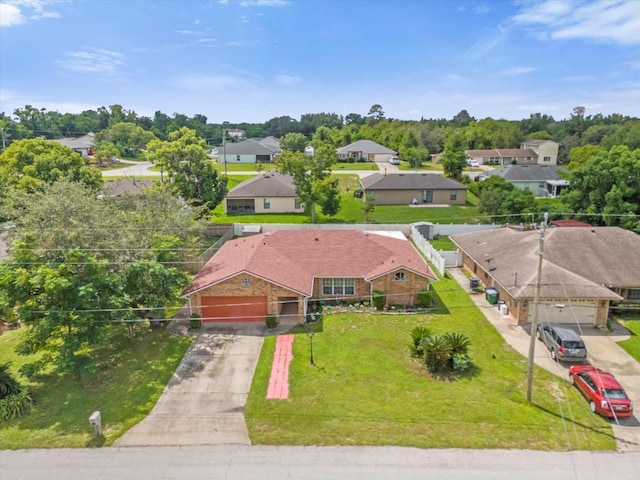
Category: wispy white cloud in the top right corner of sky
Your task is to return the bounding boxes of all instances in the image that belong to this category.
[513,0,640,45]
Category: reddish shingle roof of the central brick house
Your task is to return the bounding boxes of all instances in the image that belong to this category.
[183,230,437,296]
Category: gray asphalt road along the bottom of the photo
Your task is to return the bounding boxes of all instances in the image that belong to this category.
[0,445,640,480]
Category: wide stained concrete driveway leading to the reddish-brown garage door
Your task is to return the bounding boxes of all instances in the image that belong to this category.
[114,325,264,447]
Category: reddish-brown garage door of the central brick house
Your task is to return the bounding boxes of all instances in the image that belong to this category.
[201,297,267,322]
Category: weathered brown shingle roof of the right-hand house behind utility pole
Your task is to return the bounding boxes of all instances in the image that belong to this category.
[450,227,640,300]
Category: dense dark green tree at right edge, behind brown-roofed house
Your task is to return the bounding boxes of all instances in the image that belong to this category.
[562,145,640,232]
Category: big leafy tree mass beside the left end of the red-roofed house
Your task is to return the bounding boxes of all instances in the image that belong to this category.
[0,181,204,374]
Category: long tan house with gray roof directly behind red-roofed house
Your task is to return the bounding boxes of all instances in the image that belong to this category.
[360,172,467,205]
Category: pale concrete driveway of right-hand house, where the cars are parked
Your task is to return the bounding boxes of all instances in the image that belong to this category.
[448,268,640,452]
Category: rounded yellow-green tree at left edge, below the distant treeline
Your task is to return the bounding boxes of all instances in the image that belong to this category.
[0,138,102,191]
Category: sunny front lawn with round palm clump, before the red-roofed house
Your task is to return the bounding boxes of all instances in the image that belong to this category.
[245,279,616,450]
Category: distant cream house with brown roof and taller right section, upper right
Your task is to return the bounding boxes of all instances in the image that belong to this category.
[462,140,560,165]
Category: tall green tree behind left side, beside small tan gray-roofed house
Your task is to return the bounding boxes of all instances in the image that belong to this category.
[147,127,227,210]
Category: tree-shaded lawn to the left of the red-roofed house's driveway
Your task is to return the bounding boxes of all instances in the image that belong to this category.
[0,327,191,450]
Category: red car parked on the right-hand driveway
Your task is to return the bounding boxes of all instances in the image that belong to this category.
[569,365,633,418]
